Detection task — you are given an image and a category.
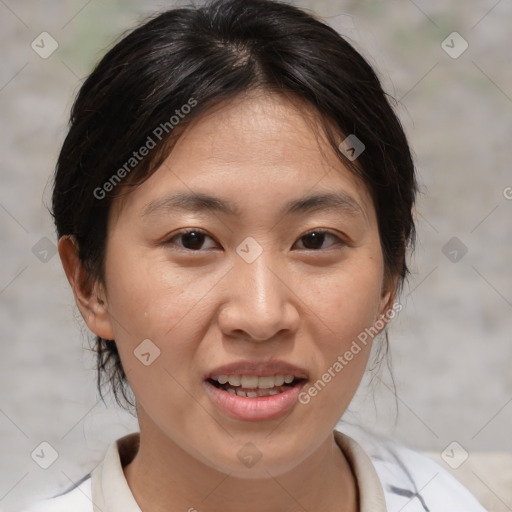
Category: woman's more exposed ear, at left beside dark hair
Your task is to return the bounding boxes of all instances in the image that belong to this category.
[58,235,114,340]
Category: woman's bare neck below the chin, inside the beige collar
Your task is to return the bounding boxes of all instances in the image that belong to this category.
[124,418,358,512]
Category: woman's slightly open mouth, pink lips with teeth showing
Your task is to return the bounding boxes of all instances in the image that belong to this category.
[204,362,307,421]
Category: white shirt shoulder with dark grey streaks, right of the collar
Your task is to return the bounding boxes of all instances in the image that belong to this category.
[340,431,485,512]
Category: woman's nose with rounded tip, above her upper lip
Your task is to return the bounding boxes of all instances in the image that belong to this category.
[218,251,300,341]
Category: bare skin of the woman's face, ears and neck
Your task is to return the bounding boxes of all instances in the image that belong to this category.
[59,91,396,512]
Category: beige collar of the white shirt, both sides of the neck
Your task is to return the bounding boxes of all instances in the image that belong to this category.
[92,430,386,512]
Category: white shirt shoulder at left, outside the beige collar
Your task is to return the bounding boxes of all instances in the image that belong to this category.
[21,474,93,512]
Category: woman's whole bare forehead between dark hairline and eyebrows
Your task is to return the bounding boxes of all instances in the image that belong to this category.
[112,91,373,226]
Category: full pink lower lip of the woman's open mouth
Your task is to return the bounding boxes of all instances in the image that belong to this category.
[204,381,304,421]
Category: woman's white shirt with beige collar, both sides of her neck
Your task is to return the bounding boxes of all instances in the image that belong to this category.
[24,430,485,512]
